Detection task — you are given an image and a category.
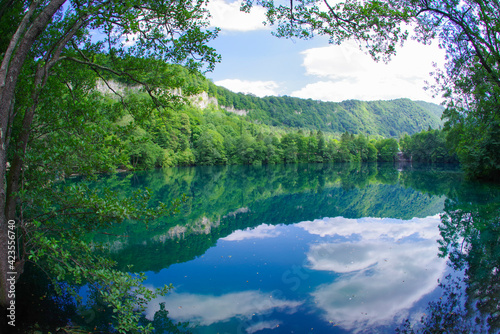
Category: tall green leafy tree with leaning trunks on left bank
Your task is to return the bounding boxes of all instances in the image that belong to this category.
[0,0,219,330]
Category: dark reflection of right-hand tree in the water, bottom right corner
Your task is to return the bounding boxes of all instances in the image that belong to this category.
[397,185,500,333]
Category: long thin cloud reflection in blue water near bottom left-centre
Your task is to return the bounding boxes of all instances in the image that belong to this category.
[146,291,303,329]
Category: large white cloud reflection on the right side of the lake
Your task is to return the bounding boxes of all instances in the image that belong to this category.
[299,216,446,332]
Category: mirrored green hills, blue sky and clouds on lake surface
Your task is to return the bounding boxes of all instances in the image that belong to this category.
[96,165,496,333]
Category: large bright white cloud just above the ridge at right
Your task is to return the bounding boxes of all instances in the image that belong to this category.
[292,41,444,102]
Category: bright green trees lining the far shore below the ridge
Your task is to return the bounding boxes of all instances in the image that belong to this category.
[124,102,412,169]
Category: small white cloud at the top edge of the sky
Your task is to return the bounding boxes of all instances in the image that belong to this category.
[207,0,269,32]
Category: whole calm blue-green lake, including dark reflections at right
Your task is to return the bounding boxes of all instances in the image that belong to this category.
[14,164,500,334]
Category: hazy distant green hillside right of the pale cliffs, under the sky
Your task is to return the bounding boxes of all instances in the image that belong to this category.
[209,84,443,137]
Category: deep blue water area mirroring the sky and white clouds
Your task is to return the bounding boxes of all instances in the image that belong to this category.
[146,216,447,333]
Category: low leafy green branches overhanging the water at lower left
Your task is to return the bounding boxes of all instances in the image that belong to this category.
[21,177,186,332]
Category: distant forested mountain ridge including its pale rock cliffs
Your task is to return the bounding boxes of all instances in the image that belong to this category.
[100,65,444,138]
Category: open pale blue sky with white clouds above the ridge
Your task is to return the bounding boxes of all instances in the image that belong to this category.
[206,0,444,103]
